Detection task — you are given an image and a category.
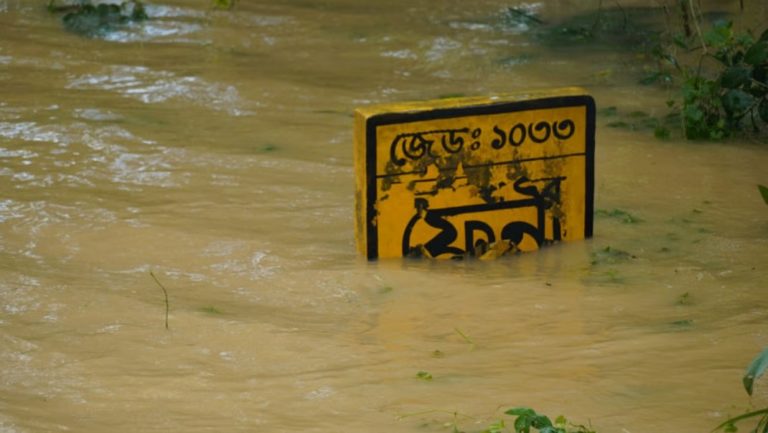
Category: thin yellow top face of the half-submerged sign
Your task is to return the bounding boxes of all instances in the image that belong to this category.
[355,87,589,117]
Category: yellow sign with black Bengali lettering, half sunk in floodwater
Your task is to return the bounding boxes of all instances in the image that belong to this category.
[355,89,595,258]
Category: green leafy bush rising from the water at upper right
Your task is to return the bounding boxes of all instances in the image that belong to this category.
[642,22,768,140]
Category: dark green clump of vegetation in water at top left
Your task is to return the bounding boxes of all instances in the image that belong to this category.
[48,0,149,37]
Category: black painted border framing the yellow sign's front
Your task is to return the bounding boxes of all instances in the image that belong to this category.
[365,95,595,260]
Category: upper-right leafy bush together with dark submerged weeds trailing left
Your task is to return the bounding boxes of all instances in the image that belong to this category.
[501,0,768,140]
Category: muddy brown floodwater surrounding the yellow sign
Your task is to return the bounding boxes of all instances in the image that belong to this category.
[0,0,768,433]
